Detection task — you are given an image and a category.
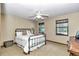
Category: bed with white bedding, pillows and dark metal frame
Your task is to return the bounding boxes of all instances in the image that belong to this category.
[15,28,46,54]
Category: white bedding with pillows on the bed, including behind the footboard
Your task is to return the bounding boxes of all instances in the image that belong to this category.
[15,32,45,53]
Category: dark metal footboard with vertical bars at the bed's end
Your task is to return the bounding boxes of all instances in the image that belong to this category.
[28,35,46,53]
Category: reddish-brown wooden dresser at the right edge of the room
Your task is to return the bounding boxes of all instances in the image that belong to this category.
[68,36,79,56]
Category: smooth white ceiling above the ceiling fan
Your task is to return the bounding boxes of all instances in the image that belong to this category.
[1,3,79,19]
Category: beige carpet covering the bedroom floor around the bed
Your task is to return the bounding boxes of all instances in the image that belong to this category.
[1,42,69,56]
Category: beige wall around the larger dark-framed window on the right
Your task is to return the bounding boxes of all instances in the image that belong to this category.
[45,12,79,44]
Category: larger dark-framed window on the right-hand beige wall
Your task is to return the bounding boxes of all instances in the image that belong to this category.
[56,19,68,36]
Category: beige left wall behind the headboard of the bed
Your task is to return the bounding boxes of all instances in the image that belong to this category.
[1,15,35,45]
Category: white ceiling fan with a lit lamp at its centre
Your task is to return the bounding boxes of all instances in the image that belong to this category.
[30,11,48,20]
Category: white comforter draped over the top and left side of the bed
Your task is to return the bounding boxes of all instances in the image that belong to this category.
[15,35,45,53]
